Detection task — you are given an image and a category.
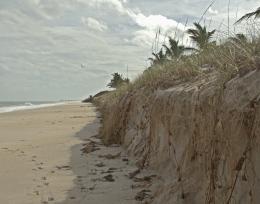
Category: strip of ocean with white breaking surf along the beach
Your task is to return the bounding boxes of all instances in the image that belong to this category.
[0,101,65,113]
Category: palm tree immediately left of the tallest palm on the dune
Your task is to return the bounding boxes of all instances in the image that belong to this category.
[163,37,187,59]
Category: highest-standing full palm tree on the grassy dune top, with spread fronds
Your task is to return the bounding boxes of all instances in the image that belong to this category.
[187,23,216,50]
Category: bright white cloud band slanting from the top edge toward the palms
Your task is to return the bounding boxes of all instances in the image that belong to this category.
[77,0,185,48]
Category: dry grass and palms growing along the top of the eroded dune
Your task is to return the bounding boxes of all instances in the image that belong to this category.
[96,15,260,107]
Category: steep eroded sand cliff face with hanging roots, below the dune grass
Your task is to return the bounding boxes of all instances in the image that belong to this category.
[99,70,260,204]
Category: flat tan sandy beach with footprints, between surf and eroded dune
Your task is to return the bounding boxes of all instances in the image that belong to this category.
[0,103,140,204]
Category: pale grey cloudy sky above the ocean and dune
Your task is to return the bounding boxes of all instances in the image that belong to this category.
[0,0,260,101]
